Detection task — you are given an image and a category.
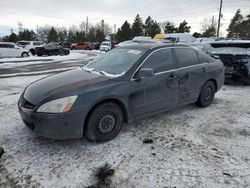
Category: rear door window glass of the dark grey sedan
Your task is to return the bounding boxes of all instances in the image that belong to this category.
[175,48,200,68]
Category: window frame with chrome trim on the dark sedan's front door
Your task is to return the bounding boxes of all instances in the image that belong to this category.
[130,47,177,81]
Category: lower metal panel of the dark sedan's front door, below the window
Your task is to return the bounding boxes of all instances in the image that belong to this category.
[130,72,179,116]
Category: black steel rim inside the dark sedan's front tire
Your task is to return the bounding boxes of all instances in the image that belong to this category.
[97,112,117,135]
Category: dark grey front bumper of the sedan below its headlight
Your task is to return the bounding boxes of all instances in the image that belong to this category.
[18,105,86,140]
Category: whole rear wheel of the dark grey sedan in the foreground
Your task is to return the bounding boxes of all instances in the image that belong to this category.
[196,81,216,107]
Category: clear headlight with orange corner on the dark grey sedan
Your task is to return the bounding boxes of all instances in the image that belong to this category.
[37,95,77,113]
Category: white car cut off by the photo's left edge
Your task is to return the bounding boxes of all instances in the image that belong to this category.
[0,42,29,58]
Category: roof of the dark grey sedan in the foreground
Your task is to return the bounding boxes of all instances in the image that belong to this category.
[119,43,191,51]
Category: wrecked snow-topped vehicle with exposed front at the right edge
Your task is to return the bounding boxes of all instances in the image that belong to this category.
[203,40,250,84]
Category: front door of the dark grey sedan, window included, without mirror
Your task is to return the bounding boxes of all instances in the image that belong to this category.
[130,48,179,116]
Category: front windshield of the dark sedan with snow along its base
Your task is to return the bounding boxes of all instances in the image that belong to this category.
[82,49,144,76]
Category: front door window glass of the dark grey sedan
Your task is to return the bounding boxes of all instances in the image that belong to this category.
[142,48,174,73]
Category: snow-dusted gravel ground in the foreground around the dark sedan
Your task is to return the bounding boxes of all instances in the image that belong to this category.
[0,56,250,188]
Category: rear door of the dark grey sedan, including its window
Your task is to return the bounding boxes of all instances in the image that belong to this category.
[174,48,207,104]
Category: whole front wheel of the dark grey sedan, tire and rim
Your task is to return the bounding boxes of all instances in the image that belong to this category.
[84,102,123,142]
